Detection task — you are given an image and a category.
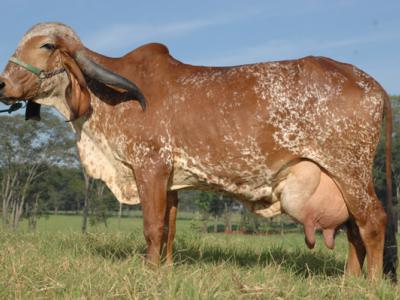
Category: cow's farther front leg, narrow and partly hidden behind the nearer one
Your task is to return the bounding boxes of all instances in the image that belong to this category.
[163,191,178,265]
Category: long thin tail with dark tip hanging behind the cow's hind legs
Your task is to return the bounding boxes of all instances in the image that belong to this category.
[383,94,398,281]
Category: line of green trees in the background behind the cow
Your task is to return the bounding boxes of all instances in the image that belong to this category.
[0,96,400,231]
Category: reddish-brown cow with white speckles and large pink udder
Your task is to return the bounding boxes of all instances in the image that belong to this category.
[0,23,391,278]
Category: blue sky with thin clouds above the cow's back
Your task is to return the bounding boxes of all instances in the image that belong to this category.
[0,0,400,94]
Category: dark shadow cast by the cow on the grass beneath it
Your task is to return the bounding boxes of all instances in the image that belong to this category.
[81,232,344,277]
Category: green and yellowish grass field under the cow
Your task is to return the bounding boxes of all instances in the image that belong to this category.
[0,216,400,299]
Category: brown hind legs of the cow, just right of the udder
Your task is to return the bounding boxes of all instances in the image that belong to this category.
[343,183,386,279]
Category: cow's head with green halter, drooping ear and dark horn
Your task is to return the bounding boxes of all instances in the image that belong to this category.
[0,23,146,120]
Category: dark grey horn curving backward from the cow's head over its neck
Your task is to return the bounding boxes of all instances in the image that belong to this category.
[75,51,146,110]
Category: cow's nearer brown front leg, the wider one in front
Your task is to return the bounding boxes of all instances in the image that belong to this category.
[135,160,170,266]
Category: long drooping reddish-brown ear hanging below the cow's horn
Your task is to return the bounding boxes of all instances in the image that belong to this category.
[61,52,90,121]
